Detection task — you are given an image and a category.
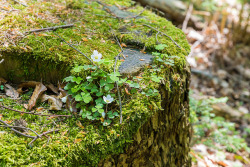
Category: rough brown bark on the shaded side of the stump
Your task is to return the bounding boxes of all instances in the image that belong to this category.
[98,63,191,167]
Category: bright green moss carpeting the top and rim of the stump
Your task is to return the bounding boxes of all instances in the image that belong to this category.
[0,0,190,166]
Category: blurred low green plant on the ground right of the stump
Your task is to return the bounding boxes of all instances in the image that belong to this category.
[190,92,250,152]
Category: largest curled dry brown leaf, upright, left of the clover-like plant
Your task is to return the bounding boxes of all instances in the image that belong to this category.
[28,82,47,110]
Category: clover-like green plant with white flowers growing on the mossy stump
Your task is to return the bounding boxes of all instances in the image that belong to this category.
[64,44,177,126]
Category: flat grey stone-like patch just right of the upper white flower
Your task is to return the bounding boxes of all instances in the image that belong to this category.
[119,49,153,74]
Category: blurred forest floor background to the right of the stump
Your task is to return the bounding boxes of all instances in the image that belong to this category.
[137,0,250,167]
